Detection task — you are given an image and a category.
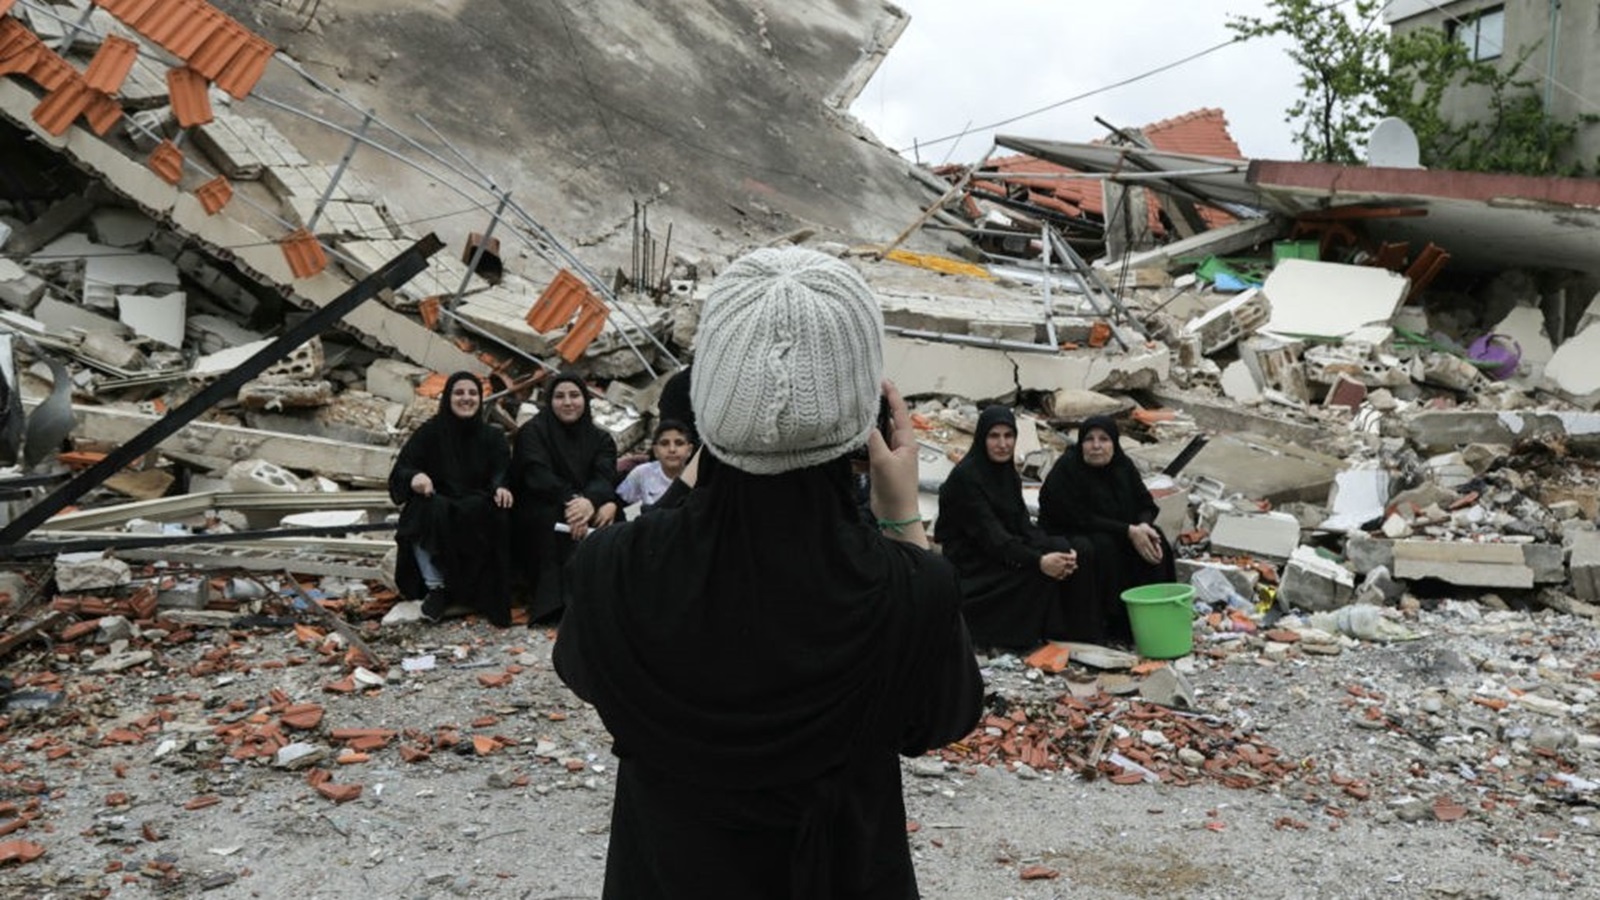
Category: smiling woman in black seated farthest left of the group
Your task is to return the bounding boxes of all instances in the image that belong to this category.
[389,372,512,626]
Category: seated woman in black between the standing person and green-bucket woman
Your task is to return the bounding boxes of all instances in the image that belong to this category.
[936,407,1099,647]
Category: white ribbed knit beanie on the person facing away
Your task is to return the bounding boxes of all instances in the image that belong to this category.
[690,247,883,476]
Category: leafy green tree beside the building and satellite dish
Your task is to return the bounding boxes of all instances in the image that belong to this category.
[1229,0,1594,175]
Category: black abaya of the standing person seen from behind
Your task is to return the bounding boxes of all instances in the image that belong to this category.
[555,448,982,900]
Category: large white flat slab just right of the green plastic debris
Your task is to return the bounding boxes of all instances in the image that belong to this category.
[1261,259,1410,338]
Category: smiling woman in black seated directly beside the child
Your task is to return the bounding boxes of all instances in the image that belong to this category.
[512,372,621,623]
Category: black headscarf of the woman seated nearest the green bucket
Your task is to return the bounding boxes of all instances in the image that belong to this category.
[1038,416,1158,533]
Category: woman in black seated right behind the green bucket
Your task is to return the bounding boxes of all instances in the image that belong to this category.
[1038,416,1176,636]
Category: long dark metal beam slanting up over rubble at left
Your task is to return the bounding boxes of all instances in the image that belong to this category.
[0,234,443,544]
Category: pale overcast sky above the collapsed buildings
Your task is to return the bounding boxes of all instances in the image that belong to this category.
[853,0,1299,162]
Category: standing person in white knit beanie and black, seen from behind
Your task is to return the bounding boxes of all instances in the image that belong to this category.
[555,248,982,900]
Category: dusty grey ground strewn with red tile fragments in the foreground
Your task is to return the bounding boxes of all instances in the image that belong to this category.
[0,586,1600,898]
